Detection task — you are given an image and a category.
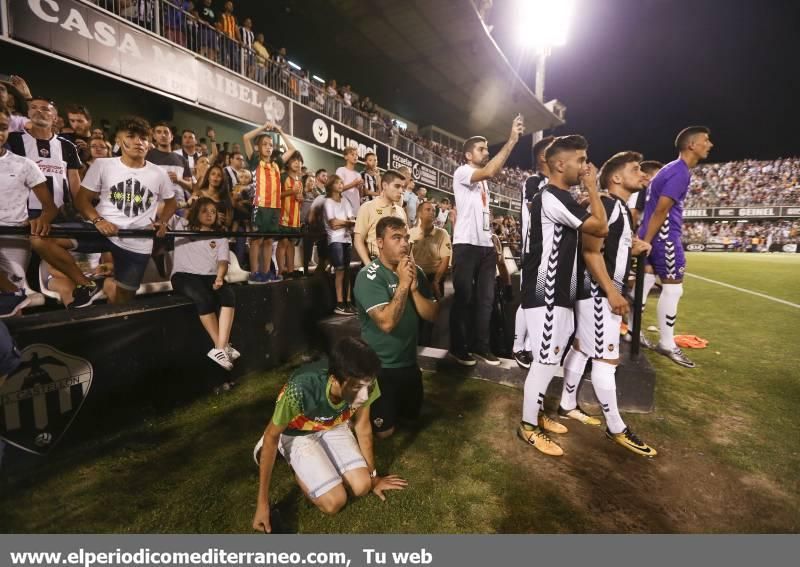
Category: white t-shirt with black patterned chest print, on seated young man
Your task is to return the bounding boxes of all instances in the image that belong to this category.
[81,158,174,254]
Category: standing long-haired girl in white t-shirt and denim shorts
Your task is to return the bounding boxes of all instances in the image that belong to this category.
[325,175,356,315]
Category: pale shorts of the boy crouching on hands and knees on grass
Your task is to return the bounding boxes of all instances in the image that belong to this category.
[278,423,367,499]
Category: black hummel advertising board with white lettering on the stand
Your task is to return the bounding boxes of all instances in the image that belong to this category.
[292,103,389,164]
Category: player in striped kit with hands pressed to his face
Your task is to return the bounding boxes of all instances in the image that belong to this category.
[517,135,608,456]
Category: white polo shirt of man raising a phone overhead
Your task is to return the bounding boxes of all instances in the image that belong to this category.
[453,164,492,246]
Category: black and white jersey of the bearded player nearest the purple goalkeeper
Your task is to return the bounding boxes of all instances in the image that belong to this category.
[578,195,633,299]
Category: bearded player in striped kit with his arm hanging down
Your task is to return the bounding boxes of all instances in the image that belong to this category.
[558,152,656,457]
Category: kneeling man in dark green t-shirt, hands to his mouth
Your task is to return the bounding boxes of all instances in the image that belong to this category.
[354,216,439,439]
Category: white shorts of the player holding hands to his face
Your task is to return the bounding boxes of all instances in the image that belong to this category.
[523,307,575,364]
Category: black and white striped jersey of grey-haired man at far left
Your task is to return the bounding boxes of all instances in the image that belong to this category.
[6,132,83,210]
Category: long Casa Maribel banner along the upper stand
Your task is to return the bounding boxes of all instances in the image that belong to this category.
[8,0,290,130]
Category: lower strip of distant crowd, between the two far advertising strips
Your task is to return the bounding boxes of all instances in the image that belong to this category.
[683,219,800,252]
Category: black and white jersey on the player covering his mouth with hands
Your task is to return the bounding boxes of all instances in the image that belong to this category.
[522,185,590,309]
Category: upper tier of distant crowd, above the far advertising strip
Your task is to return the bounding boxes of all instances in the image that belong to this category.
[684,158,800,208]
